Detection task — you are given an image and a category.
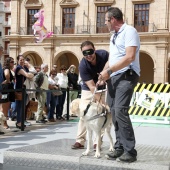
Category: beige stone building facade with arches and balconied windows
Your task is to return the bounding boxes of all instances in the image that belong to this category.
[7,0,170,83]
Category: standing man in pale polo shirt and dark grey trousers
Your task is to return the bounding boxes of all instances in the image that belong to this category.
[99,7,140,163]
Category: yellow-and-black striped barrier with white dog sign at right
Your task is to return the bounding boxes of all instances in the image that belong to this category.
[129,83,170,117]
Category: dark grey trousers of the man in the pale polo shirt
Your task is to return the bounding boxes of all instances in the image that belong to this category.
[107,71,139,156]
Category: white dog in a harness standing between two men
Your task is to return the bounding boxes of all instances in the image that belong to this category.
[70,99,113,158]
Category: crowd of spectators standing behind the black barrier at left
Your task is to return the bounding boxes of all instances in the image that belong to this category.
[0,47,78,134]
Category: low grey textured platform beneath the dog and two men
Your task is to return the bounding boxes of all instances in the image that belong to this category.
[3,139,170,170]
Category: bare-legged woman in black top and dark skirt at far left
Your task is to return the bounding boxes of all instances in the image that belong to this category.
[0,57,15,129]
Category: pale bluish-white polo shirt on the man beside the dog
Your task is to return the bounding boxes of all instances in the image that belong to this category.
[109,23,140,77]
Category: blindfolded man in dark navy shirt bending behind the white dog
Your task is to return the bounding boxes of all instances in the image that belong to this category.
[71,41,109,149]
